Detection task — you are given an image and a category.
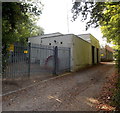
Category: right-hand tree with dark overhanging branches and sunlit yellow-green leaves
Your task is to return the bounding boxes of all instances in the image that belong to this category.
[72,2,120,72]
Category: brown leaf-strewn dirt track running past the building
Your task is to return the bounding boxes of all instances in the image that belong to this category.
[2,63,115,111]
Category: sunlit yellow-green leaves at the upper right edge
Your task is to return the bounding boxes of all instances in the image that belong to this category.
[100,3,120,44]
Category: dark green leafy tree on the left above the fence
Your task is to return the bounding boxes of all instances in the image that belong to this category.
[2,2,44,73]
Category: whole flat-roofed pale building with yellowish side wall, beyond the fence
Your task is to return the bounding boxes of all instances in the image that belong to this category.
[28,33,100,71]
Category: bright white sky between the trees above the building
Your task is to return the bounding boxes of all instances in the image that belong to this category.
[37,0,111,45]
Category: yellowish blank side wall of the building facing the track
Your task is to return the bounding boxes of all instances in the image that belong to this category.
[73,36,92,71]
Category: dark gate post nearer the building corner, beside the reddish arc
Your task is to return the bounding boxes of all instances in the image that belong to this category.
[53,46,58,75]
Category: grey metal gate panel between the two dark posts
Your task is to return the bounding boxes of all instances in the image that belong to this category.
[30,44,54,75]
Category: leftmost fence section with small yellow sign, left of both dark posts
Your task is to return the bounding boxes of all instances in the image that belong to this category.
[3,44,28,78]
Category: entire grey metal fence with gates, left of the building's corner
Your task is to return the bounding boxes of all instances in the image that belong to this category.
[3,43,70,78]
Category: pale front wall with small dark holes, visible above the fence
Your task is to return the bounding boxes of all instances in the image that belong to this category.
[29,34,73,71]
